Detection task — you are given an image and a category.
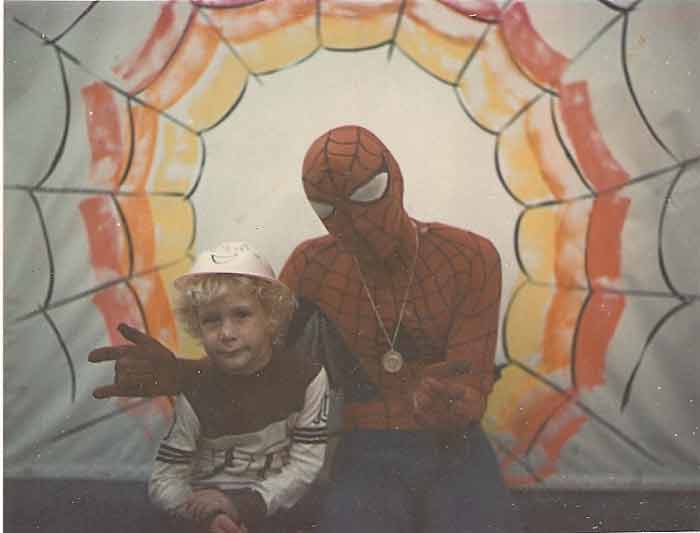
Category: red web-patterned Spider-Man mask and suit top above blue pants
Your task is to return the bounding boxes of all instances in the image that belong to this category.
[280,126,501,429]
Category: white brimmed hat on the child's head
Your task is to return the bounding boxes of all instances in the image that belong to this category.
[174,242,280,289]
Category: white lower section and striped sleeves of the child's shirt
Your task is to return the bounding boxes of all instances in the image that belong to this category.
[149,369,330,514]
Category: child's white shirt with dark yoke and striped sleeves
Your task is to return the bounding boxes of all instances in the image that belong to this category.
[149,351,329,523]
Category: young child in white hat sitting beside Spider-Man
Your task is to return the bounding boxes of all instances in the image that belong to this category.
[149,242,328,533]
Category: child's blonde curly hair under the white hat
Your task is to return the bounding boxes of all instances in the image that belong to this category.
[175,274,297,346]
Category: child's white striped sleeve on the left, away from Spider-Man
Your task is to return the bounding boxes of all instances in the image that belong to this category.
[148,394,199,517]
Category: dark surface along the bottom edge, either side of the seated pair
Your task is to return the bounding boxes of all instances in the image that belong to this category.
[4,479,700,533]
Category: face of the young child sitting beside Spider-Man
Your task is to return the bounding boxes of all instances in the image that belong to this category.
[197,288,272,375]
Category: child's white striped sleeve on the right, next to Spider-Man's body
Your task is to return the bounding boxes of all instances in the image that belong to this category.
[259,368,329,515]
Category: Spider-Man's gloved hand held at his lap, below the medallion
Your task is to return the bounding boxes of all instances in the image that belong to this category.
[413,361,486,431]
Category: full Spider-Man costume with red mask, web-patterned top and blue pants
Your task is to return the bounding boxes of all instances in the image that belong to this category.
[89,126,518,533]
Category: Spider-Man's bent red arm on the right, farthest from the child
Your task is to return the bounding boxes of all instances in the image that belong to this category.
[415,238,501,430]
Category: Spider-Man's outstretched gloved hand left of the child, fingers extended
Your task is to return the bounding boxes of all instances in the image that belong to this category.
[88,324,182,398]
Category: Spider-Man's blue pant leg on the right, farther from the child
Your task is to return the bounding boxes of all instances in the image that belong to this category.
[421,426,521,533]
